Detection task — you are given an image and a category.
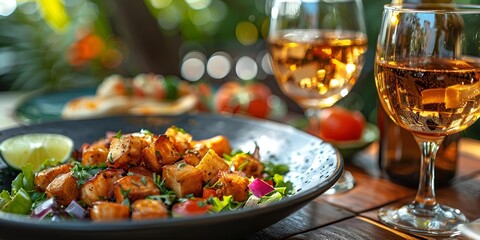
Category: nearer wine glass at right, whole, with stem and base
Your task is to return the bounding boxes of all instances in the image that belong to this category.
[375,4,480,236]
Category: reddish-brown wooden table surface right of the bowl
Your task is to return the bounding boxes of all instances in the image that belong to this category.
[247,138,480,240]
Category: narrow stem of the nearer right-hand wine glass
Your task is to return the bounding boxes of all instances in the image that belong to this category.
[412,134,444,216]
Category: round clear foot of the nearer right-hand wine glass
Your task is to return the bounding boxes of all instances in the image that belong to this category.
[378,204,468,236]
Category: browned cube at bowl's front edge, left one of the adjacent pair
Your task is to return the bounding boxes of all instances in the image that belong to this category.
[90,201,130,221]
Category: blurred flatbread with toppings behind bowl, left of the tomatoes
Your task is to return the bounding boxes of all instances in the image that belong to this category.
[62,73,198,119]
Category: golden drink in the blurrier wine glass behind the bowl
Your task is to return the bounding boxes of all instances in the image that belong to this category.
[269,30,367,108]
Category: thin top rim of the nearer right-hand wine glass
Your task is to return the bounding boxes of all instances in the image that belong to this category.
[383,3,480,14]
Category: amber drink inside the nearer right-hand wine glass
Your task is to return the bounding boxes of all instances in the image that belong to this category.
[376,58,480,135]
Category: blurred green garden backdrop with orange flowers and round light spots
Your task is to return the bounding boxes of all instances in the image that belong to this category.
[0,0,480,138]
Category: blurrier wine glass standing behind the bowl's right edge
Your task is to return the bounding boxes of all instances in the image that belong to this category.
[268,0,367,194]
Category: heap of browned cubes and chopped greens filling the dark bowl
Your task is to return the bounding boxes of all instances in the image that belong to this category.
[0,126,294,221]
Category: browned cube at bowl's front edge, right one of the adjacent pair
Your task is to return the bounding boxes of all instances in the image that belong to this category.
[132,199,168,220]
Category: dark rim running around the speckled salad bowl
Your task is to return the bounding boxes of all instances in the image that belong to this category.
[0,113,344,233]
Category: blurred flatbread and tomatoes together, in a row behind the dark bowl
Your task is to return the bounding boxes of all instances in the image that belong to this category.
[62,73,287,120]
